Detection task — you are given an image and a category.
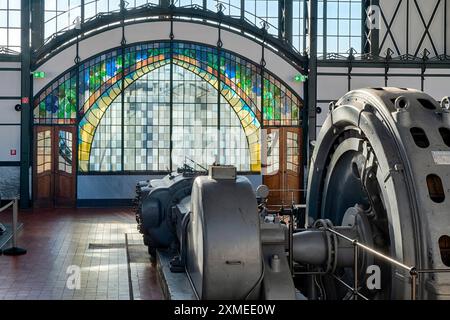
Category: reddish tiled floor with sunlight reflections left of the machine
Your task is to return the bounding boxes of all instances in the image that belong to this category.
[0,209,162,300]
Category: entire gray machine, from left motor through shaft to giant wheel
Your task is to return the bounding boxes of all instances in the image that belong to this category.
[136,88,450,300]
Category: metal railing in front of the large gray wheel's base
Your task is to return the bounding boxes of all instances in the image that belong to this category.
[325,227,450,300]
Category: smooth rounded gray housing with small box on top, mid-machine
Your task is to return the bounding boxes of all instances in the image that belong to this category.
[186,177,262,299]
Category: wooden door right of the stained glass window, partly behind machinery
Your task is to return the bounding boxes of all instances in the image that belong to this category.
[263,127,302,207]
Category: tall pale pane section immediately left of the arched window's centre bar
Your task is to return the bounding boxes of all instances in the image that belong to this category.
[124,65,170,171]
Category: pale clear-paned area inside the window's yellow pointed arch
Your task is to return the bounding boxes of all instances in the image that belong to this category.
[89,65,250,171]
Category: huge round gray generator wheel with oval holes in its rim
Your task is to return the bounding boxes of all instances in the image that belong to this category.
[307,88,450,299]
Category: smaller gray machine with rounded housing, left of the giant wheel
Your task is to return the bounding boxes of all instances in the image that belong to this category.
[137,166,295,299]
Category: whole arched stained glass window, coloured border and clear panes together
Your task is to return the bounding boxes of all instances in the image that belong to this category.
[34,42,302,172]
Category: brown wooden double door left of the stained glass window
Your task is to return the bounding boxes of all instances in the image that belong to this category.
[33,126,76,208]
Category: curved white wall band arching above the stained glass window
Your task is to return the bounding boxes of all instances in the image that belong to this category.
[34,21,303,96]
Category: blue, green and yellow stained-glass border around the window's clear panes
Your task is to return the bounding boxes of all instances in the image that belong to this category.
[34,41,302,171]
